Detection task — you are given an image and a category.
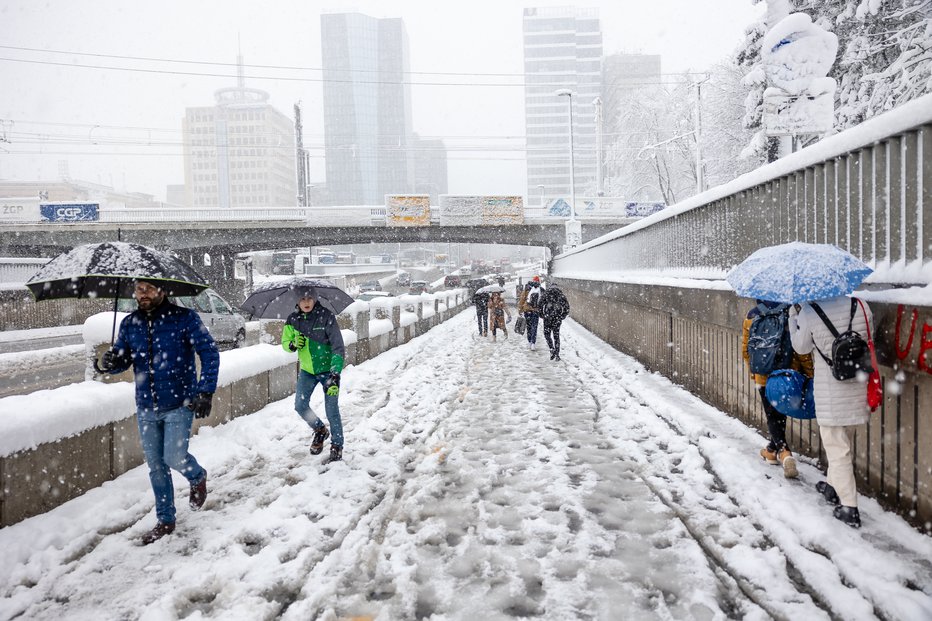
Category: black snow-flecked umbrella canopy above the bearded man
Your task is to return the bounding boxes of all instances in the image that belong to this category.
[26,242,210,301]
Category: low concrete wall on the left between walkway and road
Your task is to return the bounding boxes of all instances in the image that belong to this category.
[0,290,469,527]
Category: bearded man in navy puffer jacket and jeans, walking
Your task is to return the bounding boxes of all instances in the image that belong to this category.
[95,280,220,545]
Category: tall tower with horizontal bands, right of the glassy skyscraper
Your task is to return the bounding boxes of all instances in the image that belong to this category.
[524,7,602,204]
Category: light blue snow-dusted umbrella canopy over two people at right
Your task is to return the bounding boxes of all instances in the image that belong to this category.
[726,242,873,304]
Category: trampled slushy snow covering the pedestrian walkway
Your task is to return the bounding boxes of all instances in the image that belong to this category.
[0,311,932,621]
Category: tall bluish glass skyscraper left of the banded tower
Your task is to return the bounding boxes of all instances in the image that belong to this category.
[320,13,414,205]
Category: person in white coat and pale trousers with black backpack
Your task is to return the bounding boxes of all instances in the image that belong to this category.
[789,296,873,527]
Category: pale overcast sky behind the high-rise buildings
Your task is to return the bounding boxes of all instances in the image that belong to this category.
[0,0,761,200]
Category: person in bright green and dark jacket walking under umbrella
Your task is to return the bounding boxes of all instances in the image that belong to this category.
[282,293,345,461]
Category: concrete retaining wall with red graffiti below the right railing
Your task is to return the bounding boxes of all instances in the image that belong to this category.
[561,279,932,531]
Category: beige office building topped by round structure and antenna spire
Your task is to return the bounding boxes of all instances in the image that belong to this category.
[182,57,297,208]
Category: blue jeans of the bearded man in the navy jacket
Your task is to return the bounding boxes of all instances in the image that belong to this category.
[136,406,207,523]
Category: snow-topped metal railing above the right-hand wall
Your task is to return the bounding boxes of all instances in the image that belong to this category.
[554,95,932,283]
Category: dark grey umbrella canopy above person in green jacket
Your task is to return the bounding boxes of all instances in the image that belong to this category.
[240,277,353,319]
